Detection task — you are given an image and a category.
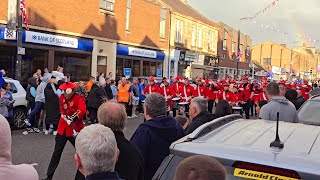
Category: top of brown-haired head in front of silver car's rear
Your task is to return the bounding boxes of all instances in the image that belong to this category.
[174,155,227,180]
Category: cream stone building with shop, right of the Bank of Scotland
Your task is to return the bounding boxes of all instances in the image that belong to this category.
[161,0,218,78]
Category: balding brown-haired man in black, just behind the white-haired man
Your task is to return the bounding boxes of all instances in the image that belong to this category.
[98,102,144,180]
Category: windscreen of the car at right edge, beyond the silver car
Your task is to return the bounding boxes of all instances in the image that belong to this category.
[298,99,320,125]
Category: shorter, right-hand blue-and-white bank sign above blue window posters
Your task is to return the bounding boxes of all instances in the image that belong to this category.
[117,45,165,61]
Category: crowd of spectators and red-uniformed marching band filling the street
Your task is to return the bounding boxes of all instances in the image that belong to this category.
[0,67,315,180]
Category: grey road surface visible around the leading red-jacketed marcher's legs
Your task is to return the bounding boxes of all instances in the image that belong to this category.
[12,115,143,180]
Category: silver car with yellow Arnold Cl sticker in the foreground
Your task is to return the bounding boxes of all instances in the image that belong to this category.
[153,115,320,180]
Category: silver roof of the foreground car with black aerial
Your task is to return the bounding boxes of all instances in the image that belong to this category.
[171,115,320,174]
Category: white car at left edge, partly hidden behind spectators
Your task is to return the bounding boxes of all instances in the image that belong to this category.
[4,78,28,129]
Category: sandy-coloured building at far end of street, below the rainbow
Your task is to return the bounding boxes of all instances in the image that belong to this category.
[252,41,318,79]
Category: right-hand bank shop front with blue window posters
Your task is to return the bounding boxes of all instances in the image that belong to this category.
[116,45,165,79]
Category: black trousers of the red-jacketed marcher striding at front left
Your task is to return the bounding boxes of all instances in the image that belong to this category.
[47,134,85,180]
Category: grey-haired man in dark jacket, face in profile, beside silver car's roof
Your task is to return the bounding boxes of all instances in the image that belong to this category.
[185,97,215,134]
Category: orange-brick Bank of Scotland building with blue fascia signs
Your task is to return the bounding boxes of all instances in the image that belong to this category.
[0,0,170,81]
